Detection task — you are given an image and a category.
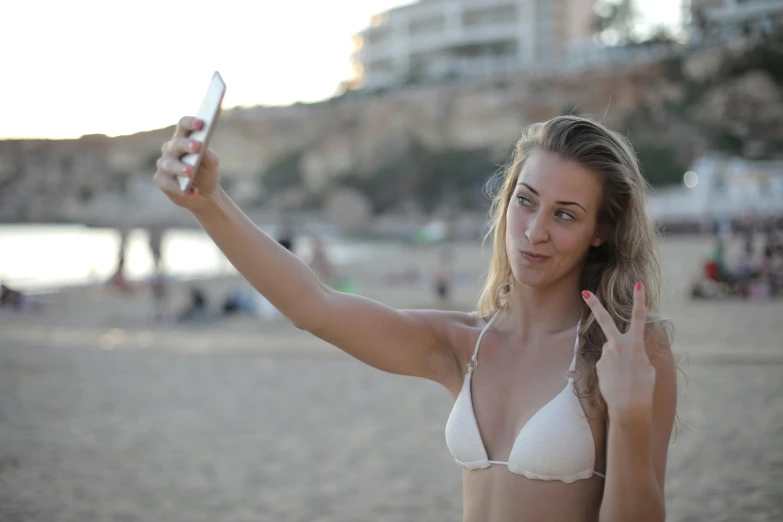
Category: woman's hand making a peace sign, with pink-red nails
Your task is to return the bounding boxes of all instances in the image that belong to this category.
[582,283,655,419]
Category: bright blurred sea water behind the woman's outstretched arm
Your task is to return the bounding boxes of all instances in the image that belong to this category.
[0,224,378,290]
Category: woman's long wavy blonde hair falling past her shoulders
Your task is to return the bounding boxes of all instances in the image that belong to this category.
[477,116,672,415]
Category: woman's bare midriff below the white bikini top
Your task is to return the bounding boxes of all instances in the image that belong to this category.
[462,464,604,522]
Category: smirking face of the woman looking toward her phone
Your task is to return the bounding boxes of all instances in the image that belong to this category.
[506,151,602,288]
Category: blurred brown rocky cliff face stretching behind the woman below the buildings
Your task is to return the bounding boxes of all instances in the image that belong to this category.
[0,41,783,222]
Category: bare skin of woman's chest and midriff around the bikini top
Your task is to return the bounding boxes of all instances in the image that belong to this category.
[448,312,606,522]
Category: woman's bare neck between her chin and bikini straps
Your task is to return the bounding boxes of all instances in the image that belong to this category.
[506,274,584,339]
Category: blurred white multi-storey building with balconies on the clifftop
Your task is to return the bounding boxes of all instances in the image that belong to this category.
[353,0,595,90]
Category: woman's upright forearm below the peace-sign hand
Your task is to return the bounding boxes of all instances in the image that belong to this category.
[599,411,666,522]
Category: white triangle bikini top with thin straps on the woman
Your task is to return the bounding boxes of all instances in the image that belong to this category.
[446,314,606,483]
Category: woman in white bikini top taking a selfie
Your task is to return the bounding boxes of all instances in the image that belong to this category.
[155,116,676,522]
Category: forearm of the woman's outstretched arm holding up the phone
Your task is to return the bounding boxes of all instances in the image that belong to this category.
[193,188,326,329]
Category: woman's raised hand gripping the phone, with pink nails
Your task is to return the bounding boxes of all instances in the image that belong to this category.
[155,116,220,212]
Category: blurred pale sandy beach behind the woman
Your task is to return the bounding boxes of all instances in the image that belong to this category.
[0,238,783,522]
